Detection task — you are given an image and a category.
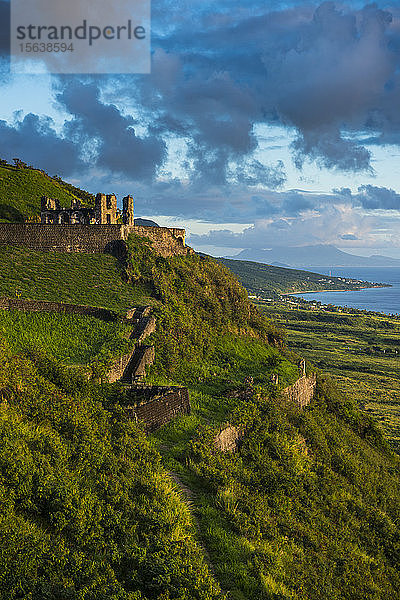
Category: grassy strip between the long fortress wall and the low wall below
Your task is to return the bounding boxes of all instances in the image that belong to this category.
[0,247,151,313]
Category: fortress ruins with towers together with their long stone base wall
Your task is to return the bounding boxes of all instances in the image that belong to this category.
[0,194,193,257]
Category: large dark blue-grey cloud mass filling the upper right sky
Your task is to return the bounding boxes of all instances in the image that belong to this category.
[144,2,400,175]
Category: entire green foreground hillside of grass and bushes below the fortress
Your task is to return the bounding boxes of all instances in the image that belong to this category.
[0,237,400,600]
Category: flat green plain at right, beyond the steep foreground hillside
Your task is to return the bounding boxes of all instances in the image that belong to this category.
[260,304,400,446]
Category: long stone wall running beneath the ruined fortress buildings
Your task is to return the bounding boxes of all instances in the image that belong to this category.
[0,223,193,257]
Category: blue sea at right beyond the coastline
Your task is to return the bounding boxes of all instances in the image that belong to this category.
[293,267,400,314]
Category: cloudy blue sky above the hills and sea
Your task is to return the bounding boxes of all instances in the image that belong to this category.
[0,0,400,258]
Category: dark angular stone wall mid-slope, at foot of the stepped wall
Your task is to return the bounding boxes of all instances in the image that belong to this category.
[126,386,190,431]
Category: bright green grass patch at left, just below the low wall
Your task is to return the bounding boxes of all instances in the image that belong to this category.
[0,310,128,365]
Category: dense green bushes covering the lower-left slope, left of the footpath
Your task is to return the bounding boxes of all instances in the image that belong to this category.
[0,343,220,600]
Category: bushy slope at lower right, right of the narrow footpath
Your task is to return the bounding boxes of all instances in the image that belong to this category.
[181,380,400,600]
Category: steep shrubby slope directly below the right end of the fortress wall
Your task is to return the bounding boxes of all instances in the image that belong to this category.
[123,235,297,387]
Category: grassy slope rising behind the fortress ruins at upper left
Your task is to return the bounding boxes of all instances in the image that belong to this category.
[0,161,94,222]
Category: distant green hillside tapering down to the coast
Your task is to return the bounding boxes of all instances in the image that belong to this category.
[218,258,382,299]
